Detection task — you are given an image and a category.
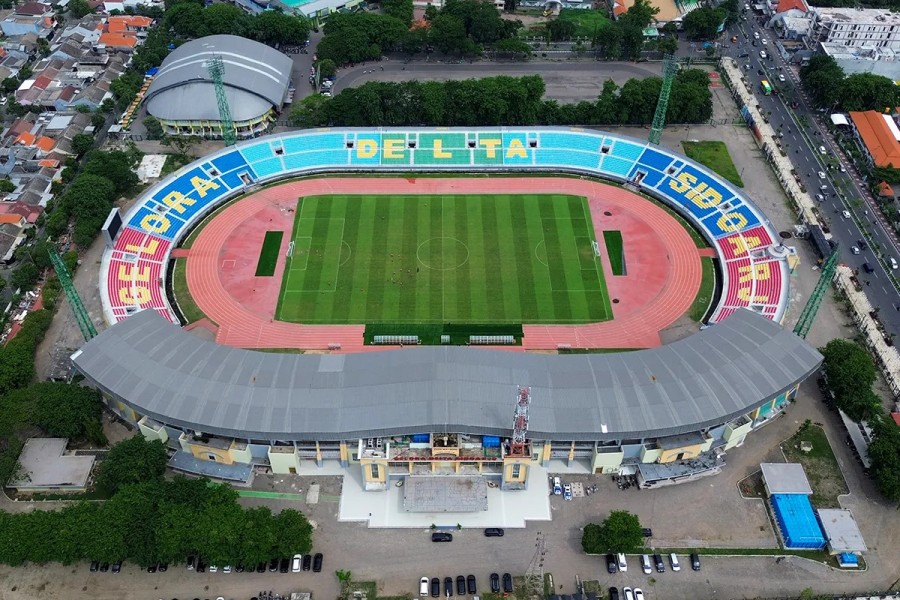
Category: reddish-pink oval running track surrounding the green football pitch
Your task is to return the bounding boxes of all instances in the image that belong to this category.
[187,177,701,352]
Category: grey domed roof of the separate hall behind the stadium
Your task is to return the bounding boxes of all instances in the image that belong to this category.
[144,35,294,121]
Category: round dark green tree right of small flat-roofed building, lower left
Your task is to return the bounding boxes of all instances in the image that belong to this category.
[97,435,168,494]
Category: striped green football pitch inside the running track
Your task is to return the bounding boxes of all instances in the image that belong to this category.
[276,194,612,324]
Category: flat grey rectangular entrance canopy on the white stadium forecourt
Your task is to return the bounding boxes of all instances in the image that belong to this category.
[402,476,488,513]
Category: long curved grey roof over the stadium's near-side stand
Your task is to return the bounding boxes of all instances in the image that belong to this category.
[73,310,822,440]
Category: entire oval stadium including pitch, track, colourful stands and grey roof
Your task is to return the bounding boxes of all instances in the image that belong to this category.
[73,128,821,491]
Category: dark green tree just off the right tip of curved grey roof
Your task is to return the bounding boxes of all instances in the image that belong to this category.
[819,339,880,421]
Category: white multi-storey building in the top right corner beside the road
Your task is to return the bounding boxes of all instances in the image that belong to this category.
[810,7,900,50]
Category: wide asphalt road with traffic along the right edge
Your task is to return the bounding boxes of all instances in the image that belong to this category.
[724,16,900,333]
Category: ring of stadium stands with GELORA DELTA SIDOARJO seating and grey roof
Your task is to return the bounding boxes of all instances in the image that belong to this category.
[73,128,821,490]
